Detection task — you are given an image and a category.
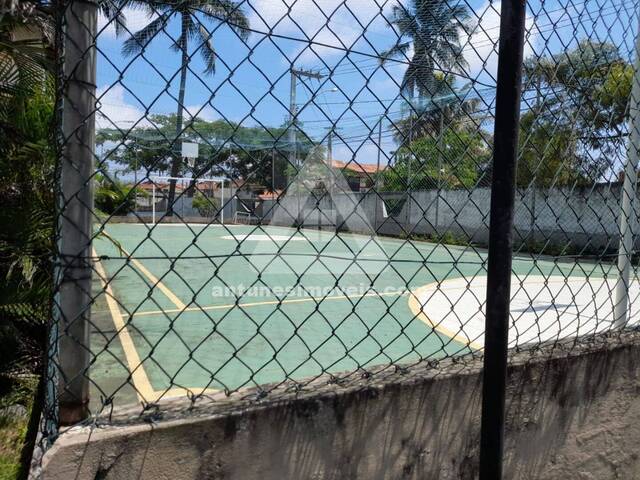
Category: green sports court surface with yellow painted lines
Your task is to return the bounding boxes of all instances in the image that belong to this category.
[91,224,608,402]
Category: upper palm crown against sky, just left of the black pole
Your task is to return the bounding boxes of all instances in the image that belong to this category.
[382,0,471,97]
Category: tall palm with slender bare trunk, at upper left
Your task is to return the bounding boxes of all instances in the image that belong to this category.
[122,0,250,216]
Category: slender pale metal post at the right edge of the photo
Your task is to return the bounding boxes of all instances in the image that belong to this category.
[613,16,640,328]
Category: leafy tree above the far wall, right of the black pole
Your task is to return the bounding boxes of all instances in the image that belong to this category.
[518,40,633,187]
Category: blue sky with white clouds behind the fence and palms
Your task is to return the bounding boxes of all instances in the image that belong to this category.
[97,0,636,172]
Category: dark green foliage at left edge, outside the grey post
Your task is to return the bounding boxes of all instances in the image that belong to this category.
[0,2,55,412]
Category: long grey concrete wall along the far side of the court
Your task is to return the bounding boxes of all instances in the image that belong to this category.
[263,184,628,249]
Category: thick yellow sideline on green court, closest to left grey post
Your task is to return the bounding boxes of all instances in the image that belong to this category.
[93,249,155,401]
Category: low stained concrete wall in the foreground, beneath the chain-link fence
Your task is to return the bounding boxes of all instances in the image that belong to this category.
[44,333,640,480]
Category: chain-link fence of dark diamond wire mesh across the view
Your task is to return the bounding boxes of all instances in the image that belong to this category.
[41,0,640,472]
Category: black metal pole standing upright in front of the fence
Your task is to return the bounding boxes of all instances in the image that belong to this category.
[480,0,526,480]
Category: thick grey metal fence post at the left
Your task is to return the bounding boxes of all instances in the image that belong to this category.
[57,0,97,424]
